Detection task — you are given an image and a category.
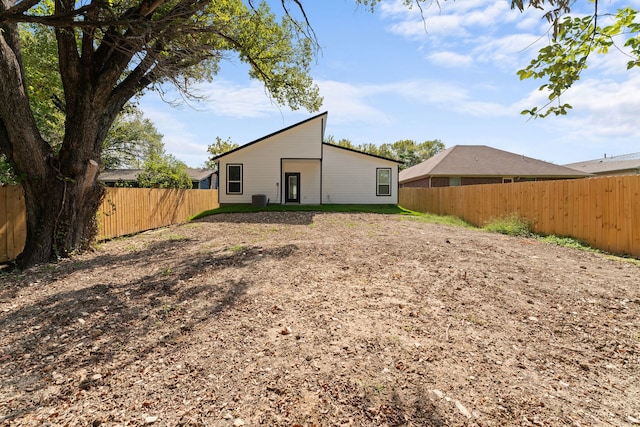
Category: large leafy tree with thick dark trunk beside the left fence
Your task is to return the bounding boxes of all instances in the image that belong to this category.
[0,0,321,267]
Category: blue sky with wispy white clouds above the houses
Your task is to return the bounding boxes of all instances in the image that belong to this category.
[140,0,640,167]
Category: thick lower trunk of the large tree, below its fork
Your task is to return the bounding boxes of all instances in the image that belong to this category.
[16,160,104,268]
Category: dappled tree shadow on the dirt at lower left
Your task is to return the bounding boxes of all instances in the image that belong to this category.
[0,239,297,422]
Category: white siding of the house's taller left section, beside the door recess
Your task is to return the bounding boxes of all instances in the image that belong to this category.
[218,115,326,204]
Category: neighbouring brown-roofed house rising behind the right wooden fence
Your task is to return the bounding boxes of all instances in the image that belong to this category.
[399,145,591,187]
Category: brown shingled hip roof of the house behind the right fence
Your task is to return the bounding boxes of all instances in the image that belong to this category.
[399,145,590,183]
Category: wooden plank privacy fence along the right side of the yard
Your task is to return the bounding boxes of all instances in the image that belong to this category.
[399,175,640,257]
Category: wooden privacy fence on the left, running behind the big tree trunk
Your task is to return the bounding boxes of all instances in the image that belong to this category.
[0,186,219,262]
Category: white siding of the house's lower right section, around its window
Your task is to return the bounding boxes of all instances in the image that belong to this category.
[322,144,398,205]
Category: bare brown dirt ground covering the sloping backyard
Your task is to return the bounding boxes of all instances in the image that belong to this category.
[0,212,640,427]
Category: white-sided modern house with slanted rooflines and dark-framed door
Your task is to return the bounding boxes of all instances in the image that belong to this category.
[212,112,400,205]
